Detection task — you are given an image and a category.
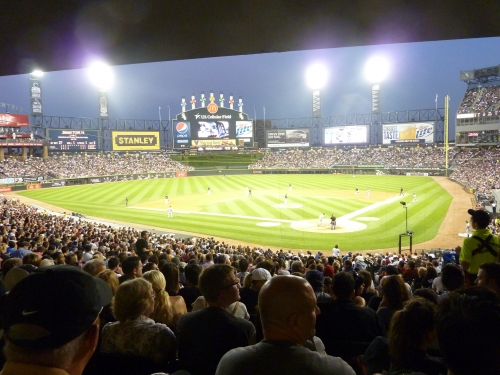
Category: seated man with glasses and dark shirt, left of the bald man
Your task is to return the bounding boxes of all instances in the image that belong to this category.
[177,264,255,375]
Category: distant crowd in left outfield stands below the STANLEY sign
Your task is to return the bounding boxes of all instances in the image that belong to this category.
[0,153,193,178]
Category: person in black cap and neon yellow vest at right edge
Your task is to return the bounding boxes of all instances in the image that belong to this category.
[459,209,500,285]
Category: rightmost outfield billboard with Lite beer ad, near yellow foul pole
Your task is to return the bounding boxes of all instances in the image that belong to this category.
[382,122,434,144]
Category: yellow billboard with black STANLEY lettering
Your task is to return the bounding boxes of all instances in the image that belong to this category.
[111,131,160,151]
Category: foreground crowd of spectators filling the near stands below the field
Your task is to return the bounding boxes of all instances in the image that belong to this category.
[0,198,500,375]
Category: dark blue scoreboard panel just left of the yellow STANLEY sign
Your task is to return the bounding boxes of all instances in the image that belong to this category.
[47,129,99,151]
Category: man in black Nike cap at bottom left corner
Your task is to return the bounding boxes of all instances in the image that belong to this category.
[0,266,112,375]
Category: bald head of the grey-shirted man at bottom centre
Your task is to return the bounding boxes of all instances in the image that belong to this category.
[259,276,319,344]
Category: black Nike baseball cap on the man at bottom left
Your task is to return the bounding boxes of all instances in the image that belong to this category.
[3,265,113,349]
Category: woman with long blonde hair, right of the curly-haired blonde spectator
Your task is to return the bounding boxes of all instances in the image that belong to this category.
[142,270,187,328]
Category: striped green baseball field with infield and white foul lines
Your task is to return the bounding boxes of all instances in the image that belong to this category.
[19,174,452,250]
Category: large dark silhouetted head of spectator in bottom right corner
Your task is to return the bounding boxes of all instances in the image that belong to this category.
[436,286,500,375]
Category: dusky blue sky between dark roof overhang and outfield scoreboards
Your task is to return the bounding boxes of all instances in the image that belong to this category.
[0,37,500,134]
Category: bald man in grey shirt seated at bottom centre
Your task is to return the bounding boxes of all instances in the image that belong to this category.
[216,276,354,375]
